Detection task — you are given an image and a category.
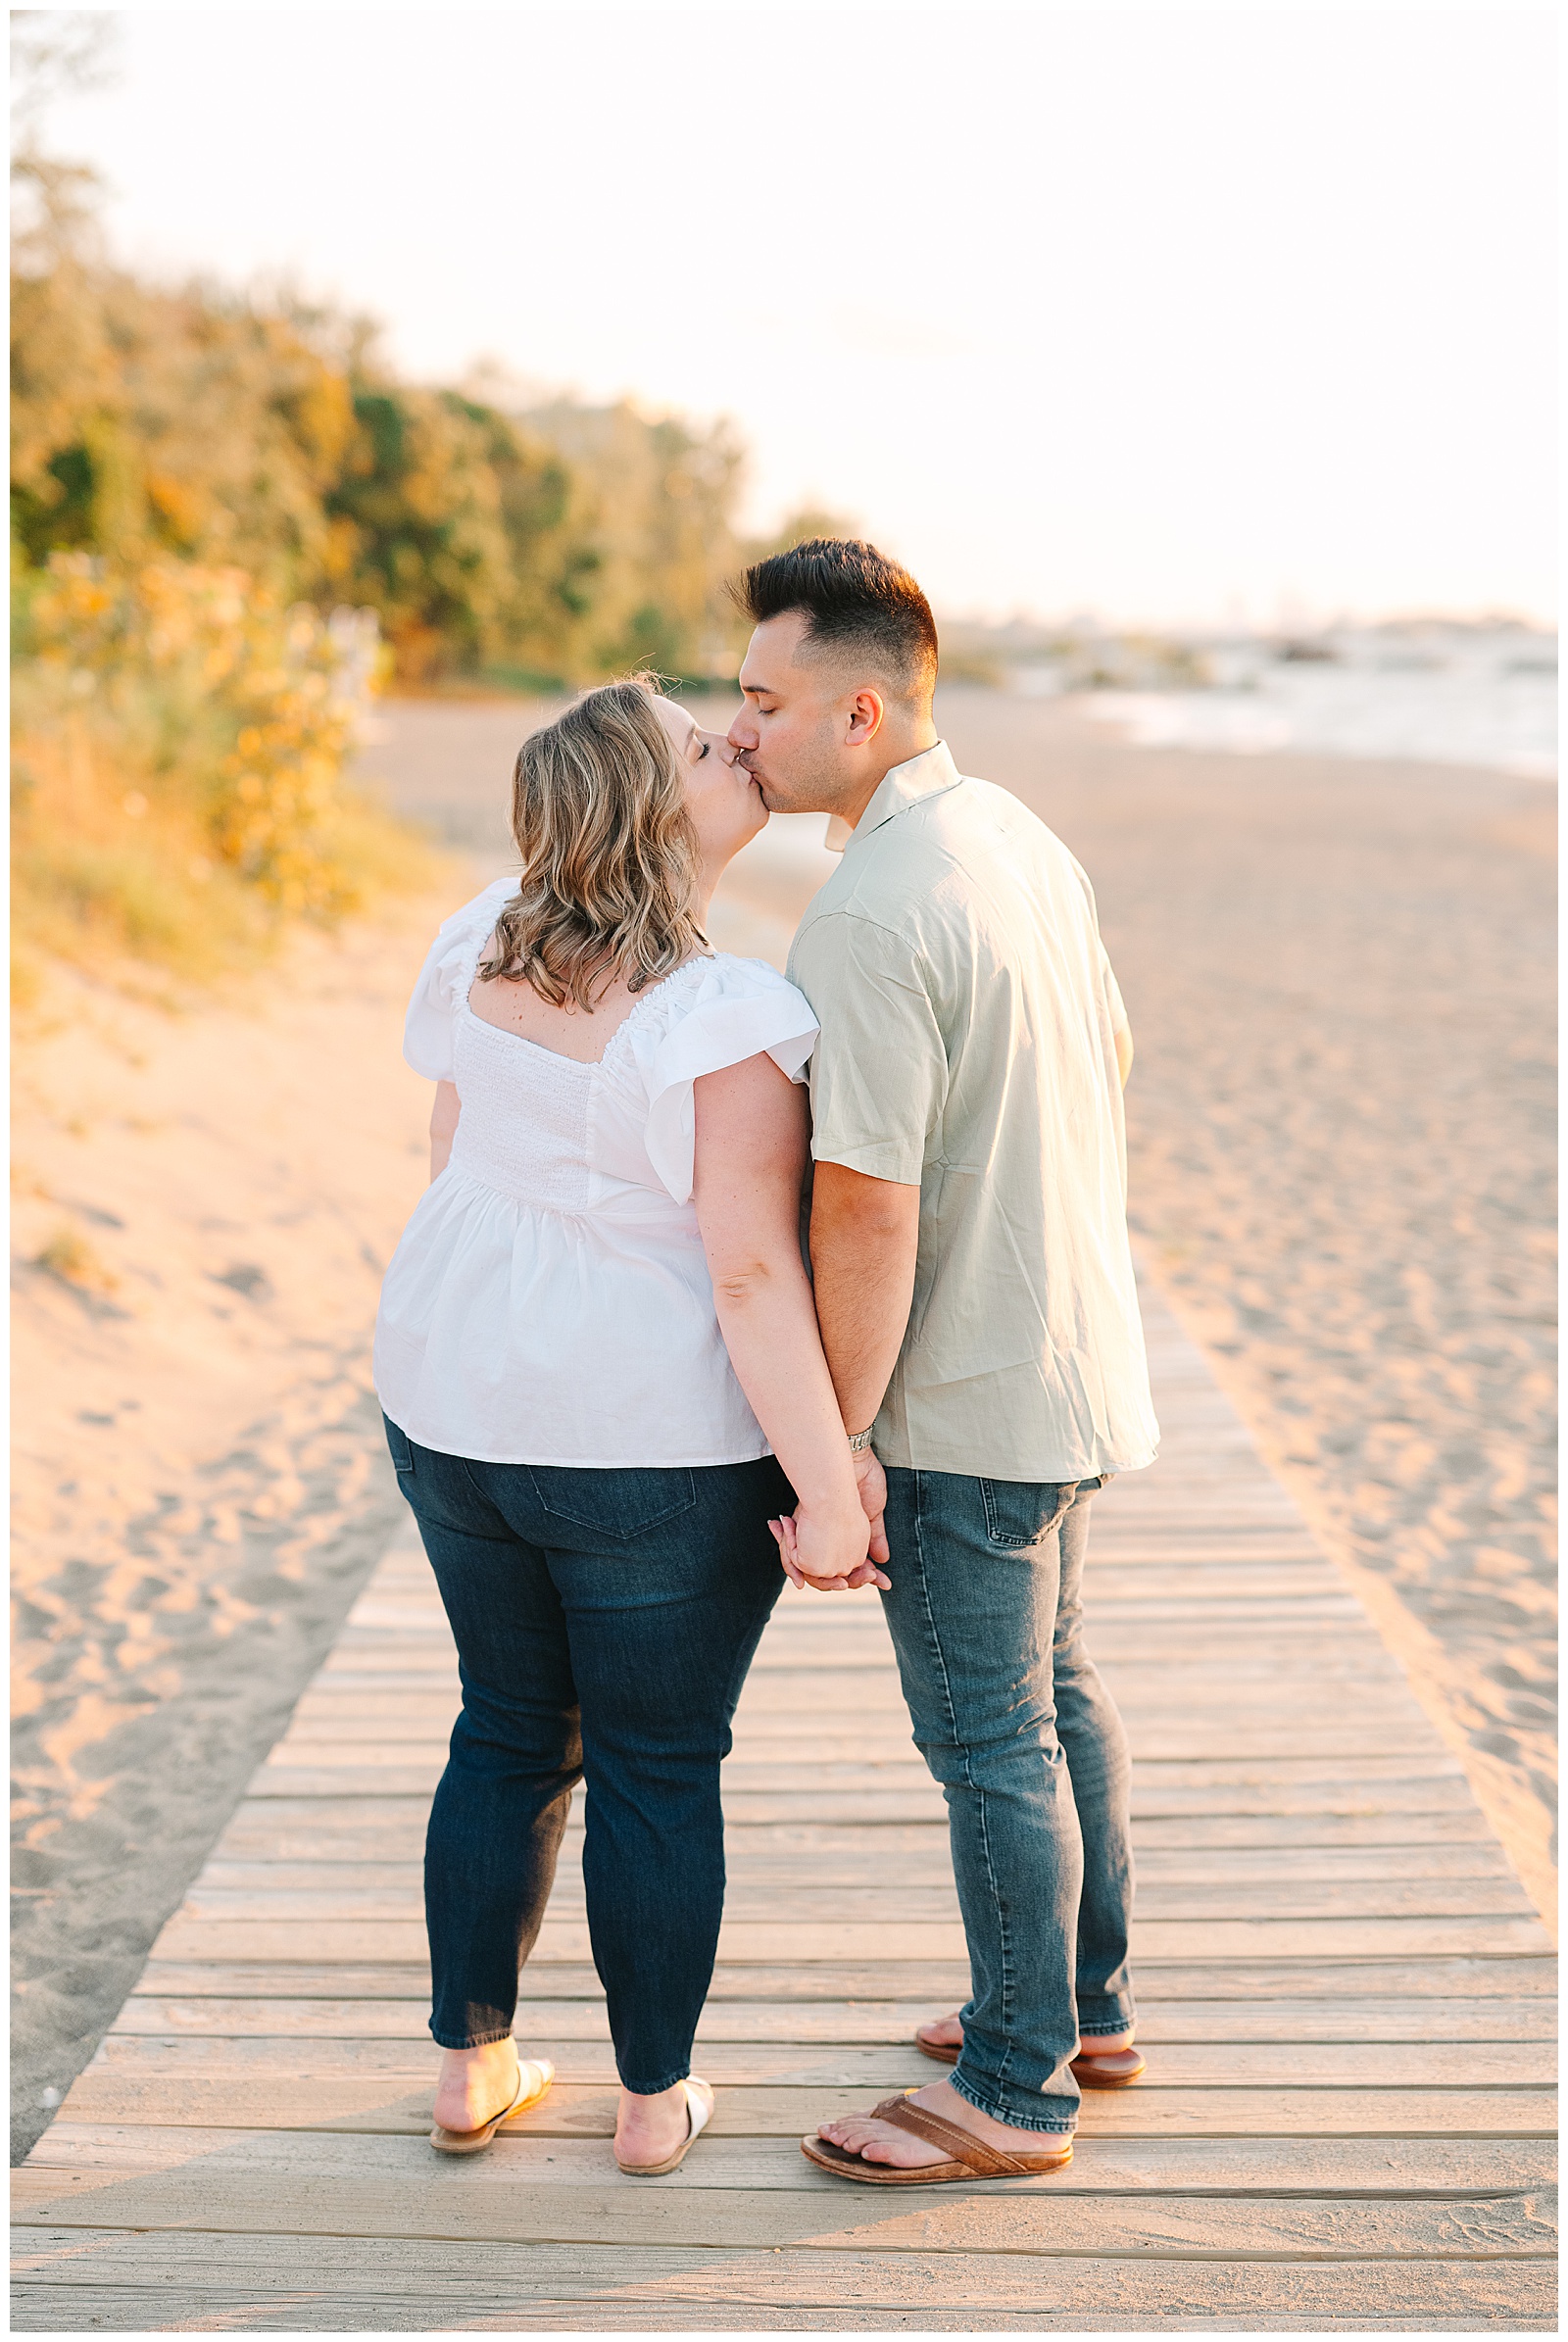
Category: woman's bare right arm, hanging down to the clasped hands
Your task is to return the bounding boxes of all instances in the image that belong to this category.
[692,1056,886,1586]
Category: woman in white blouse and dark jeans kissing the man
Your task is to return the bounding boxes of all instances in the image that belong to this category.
[375,677,886,2173]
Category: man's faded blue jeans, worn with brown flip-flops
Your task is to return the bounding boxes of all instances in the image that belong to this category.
[881,1466,1132,2131]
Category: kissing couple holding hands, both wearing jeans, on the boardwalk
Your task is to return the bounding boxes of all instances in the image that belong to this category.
[375,539,1157,2185]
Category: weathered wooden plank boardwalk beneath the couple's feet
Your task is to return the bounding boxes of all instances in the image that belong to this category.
[17,1297,1554,2332]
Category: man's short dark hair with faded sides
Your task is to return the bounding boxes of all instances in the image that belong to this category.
[736,536,938,698]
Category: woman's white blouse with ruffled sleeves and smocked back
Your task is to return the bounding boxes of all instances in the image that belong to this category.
[375,878,818,1471]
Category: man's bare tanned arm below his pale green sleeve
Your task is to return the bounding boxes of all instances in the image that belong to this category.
[811,1164,921,1431]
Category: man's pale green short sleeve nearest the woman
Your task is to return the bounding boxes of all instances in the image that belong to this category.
[790,911,947,1188]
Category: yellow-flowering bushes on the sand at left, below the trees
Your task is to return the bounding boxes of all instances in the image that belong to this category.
[14,555,429,1000]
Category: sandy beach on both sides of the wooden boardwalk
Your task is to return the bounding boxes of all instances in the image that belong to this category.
[14,689,1554,2148]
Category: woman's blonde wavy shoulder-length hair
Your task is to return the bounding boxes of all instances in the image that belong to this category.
[478,674,708,1009]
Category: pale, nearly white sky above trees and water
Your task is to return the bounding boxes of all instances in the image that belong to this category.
[36,7,1556,623]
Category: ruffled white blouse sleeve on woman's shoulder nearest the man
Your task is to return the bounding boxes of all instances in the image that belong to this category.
[638,958,818,1203]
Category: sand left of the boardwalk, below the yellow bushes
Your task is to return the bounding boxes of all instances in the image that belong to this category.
[12,873,462,2150]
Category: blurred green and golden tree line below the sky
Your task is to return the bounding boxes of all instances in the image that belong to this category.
[12,182,787,689]
